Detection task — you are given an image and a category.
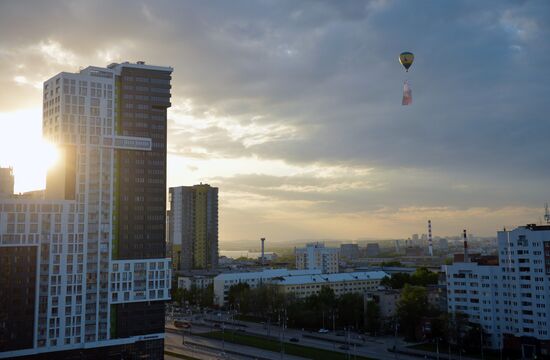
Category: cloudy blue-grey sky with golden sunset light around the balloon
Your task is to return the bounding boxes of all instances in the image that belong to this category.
[0,0,550,247]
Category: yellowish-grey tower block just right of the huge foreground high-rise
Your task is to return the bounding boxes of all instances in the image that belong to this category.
[169,184,218,271]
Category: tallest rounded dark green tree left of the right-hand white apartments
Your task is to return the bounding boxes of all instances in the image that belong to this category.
[397,284,428,340]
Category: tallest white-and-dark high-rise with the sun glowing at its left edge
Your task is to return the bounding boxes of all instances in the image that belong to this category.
[0,62,172,359]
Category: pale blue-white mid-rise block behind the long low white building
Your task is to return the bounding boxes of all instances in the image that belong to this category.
[295,242,340,274]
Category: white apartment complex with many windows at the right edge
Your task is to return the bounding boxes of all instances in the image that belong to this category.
[446,224,550,359]
